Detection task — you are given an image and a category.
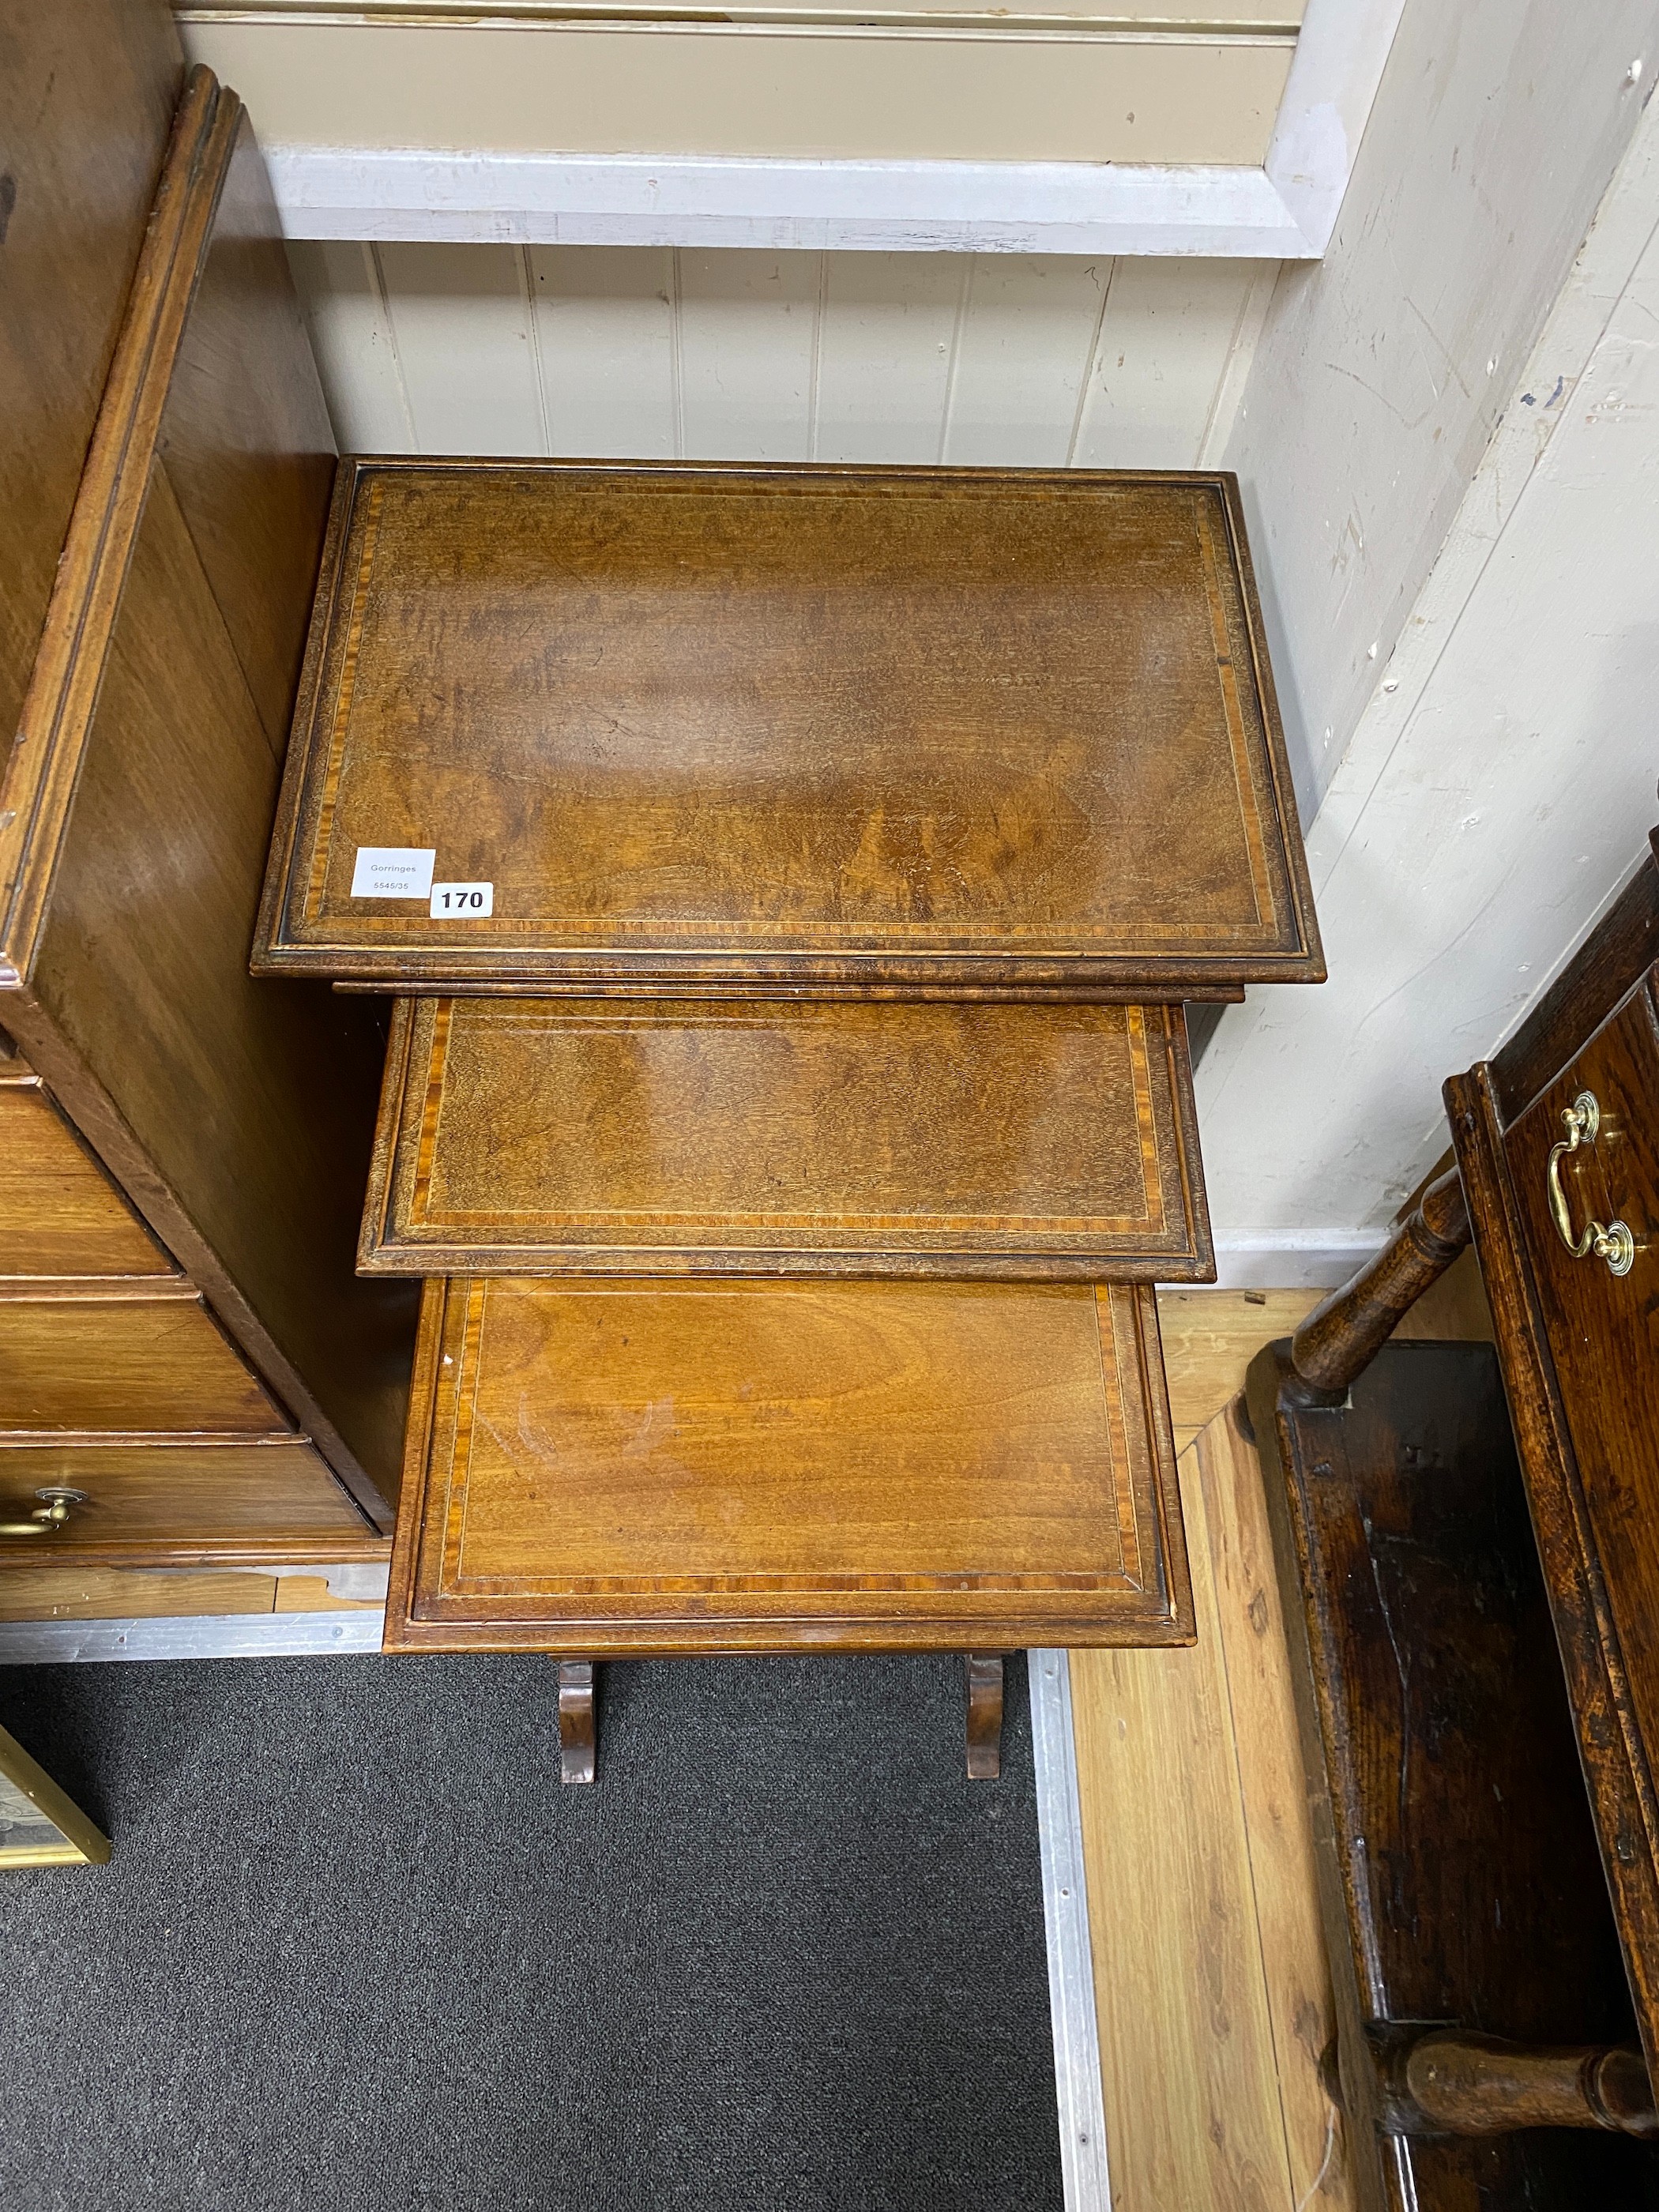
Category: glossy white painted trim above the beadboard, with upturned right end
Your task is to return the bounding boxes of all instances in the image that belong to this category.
[214,0,1405,261]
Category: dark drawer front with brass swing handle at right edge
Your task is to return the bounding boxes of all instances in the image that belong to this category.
[1504,980,1659,1750]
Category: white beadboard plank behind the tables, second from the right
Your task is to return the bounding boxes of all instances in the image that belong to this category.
[940,254,1112,469]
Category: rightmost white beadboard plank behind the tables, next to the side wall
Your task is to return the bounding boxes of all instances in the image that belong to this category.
[1073,261,1261,469]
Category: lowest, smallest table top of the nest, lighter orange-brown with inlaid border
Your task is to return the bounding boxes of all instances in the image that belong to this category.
[387,1278,1190,1653]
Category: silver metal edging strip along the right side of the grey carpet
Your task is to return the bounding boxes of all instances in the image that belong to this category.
[1026,1650,1112,2212]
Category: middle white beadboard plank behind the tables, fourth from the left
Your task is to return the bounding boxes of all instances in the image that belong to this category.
[679,250,823,460]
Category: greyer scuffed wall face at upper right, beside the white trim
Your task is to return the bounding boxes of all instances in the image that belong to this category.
[1225,0,1659,818]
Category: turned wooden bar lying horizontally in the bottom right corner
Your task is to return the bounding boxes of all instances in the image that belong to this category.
[1389,2029,1659,2135]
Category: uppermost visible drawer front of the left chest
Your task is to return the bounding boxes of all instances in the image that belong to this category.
[0,1078,172,1278]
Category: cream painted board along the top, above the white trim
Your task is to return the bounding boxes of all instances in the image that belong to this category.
[179,9,1296,164]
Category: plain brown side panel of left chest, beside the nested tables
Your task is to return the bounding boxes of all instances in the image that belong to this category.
[20,469,414,1515]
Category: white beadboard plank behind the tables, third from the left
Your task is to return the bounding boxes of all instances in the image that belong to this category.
[529,246,679,460]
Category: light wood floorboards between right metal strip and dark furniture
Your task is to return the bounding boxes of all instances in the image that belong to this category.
[1070,1398,1354,2212]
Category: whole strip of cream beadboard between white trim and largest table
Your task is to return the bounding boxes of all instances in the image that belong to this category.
[290,241,1277,469]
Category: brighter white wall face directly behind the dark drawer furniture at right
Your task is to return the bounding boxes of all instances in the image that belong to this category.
[1199,102,1659,1283]
